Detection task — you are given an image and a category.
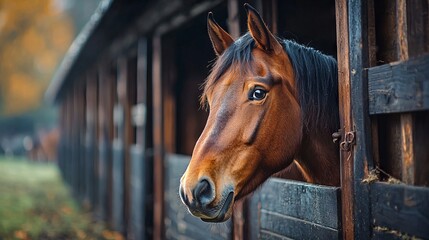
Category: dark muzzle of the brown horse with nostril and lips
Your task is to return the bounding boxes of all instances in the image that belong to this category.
[179,178,234,222]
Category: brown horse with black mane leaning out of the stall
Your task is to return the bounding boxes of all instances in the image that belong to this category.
[179,4,340,222]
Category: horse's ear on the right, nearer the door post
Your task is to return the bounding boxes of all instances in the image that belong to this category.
[244,3,283,54]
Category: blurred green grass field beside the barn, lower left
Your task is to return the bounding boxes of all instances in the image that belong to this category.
[0,156,122,240]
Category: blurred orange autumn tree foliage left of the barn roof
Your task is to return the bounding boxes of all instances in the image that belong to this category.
[0,0,74,116]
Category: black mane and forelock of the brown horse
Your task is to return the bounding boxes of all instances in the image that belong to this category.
[201,33,339,132]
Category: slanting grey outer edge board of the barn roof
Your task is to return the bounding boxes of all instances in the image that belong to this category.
[45,0,145,103]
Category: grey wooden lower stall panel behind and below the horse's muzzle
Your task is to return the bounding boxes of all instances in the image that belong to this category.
[164,154,232,239]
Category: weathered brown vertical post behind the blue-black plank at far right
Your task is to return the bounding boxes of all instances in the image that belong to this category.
[398,0,429,186]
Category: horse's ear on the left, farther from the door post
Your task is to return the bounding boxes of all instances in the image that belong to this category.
[207,12,234,56]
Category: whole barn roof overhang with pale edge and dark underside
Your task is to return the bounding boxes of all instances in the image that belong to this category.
[45,0,223,103]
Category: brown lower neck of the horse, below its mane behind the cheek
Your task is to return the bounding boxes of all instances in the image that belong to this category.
[296,131,340,186]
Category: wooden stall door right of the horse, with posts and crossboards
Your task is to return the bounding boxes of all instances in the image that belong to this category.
[337,0,429,239]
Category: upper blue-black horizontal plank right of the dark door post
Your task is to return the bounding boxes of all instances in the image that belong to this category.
[368,55,429,114]
